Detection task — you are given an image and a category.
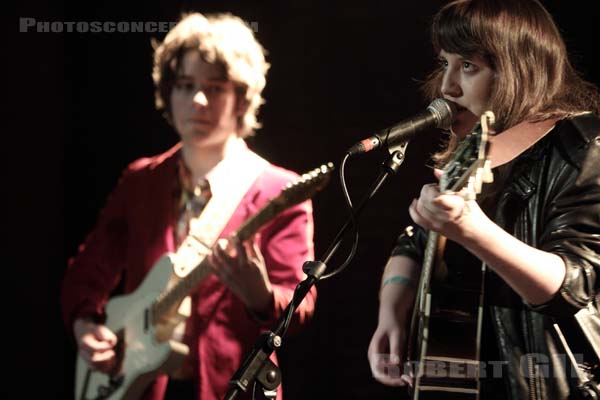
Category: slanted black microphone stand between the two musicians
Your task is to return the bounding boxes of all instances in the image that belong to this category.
[224,142,408,400]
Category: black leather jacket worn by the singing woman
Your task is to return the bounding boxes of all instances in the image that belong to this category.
[392,114,600,399]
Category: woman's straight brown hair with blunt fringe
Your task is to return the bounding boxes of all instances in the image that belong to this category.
[423,0,600,161]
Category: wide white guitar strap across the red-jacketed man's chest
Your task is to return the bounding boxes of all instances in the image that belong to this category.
[173,139,268,278]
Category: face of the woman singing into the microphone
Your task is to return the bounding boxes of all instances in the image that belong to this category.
[439,50,495,137]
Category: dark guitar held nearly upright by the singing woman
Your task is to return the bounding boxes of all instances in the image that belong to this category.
[407,111,494,400]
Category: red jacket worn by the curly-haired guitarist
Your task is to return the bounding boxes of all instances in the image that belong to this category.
[62,145,316,400]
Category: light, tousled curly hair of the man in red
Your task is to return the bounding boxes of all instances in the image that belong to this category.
[152,13,270,137]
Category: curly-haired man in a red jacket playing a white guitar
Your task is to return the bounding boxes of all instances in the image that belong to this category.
[62,13,316,400]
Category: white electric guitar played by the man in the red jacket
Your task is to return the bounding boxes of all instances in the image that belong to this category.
[75,163,333,400]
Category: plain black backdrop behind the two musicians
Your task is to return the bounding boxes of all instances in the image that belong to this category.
[8,0,600,399]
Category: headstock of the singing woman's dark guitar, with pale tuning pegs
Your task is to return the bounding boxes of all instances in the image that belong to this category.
[440,111,495,200]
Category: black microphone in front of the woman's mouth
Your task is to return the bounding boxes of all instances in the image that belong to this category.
[346,98,456,156]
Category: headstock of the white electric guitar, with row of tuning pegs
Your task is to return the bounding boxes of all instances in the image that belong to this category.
[273,163,334,206]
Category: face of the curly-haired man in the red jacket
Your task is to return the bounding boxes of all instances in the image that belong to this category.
[171,50,245,147]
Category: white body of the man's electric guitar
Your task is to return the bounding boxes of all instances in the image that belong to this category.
[75,254,189,400]
